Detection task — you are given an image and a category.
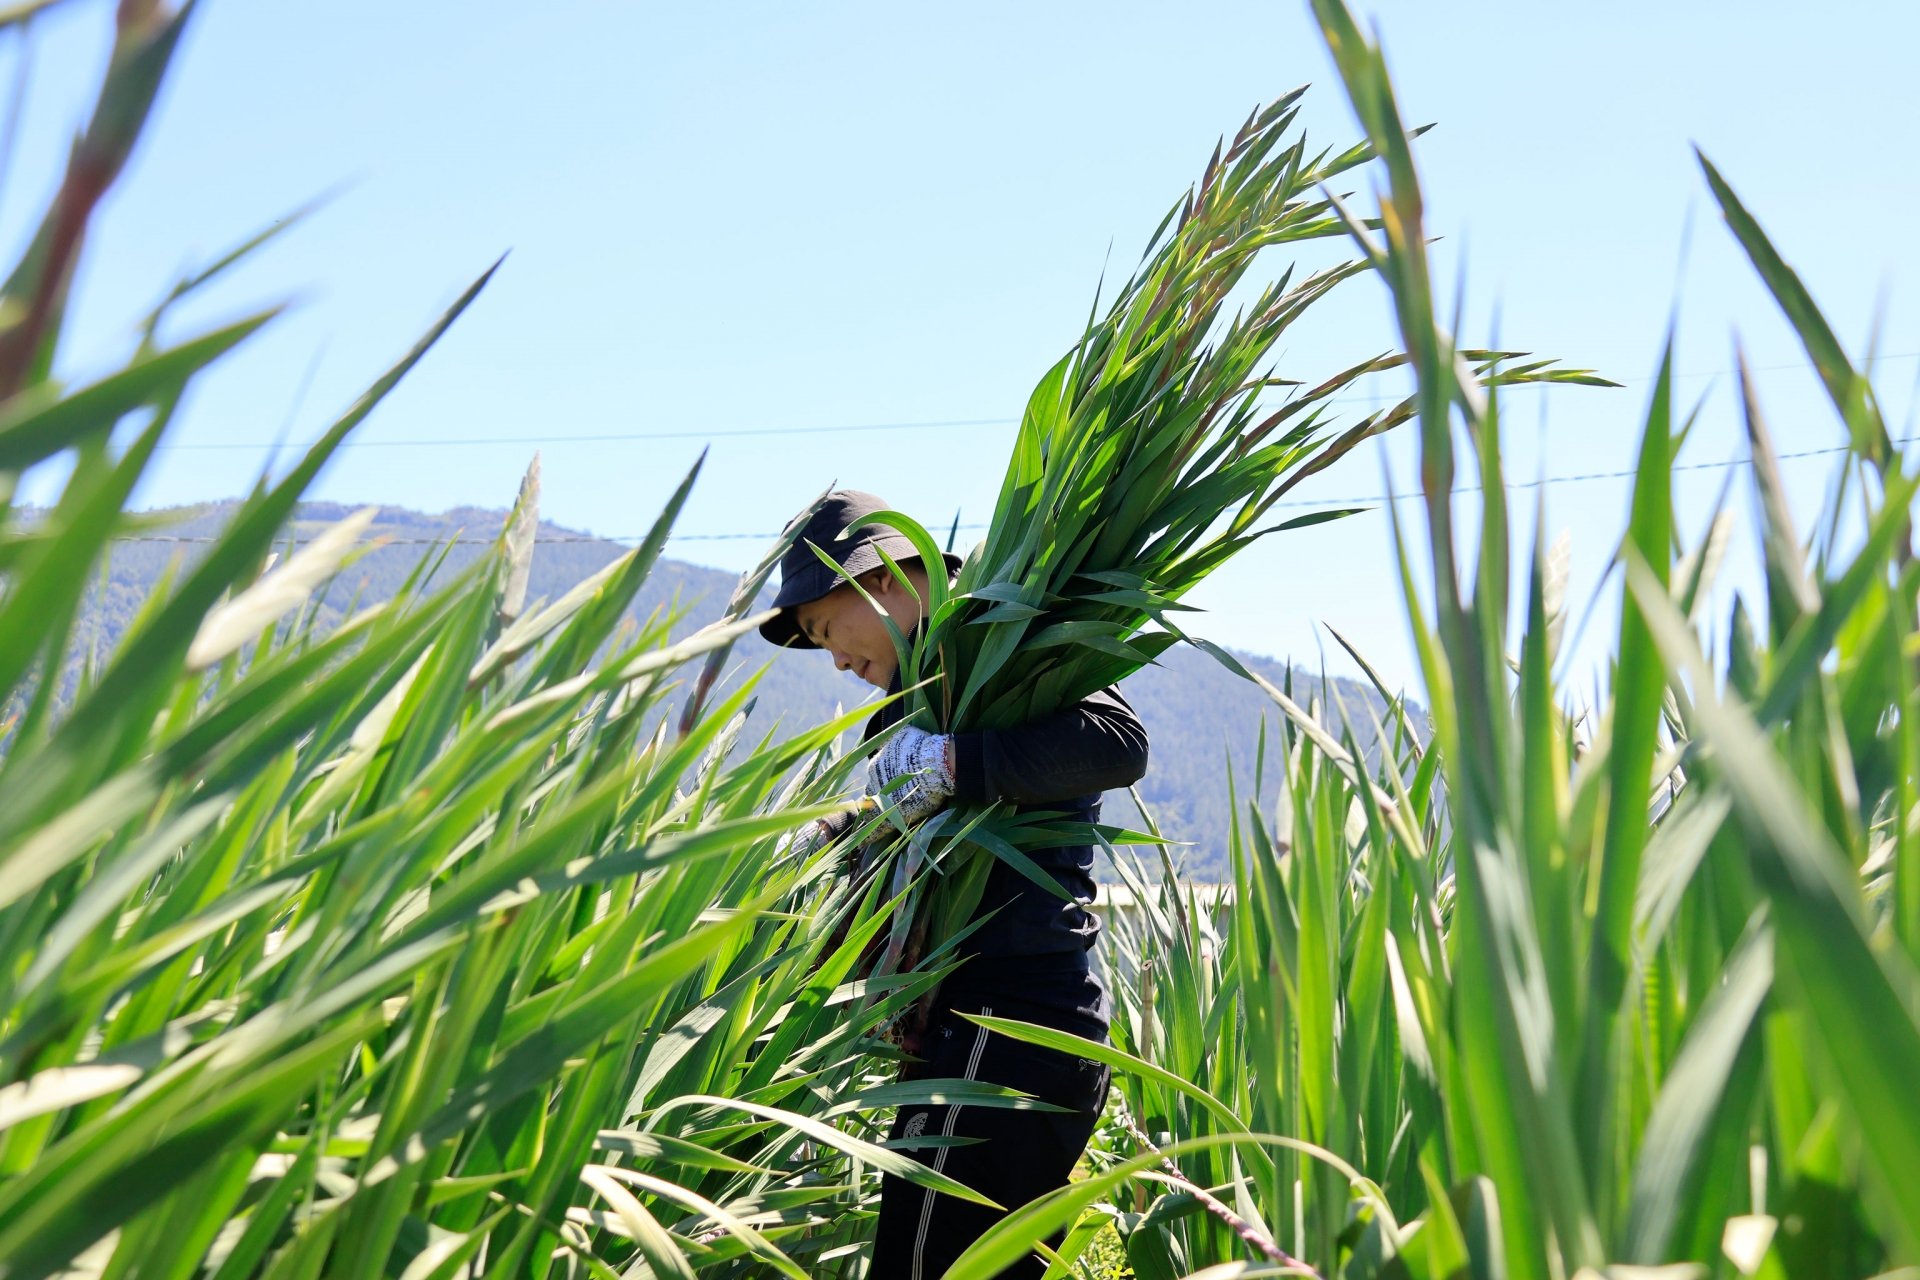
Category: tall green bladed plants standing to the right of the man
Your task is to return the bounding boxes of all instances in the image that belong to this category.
[950,0,1920,1280]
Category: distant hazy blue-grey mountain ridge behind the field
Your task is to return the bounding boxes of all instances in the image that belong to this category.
[67,503,1425,881]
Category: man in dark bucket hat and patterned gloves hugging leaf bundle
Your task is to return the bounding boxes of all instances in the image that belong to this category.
[760,489,1146,1280]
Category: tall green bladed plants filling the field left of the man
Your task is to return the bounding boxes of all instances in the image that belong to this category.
[0,4,1025,1280]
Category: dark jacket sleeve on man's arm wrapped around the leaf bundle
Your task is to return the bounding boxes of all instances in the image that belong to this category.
[954,689,1146,804]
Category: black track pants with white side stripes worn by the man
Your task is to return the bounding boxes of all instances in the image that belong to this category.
[868,1000,1108,1280]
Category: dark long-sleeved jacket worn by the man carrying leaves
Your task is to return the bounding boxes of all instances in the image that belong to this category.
[864,687,1146,974]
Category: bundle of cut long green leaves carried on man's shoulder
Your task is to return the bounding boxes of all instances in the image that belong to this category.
[840,88,1607,959]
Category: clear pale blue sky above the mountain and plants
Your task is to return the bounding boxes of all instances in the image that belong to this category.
[18,0,1920,702]
